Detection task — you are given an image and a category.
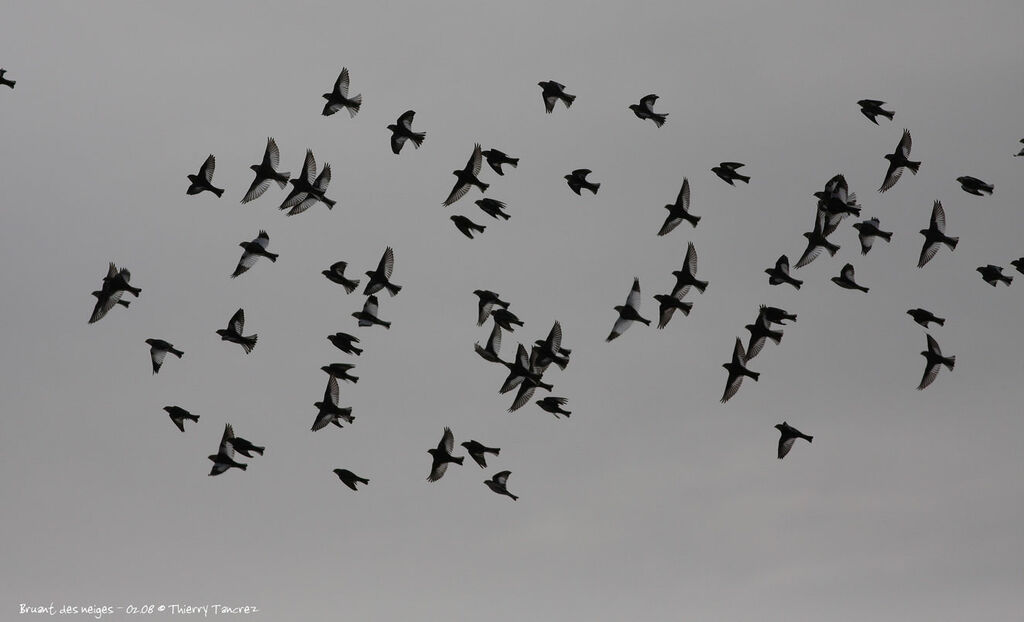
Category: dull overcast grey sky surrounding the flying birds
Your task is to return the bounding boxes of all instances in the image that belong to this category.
[0,1,1024,622]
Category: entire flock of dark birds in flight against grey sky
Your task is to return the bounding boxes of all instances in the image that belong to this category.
[0,59,1024,500]
